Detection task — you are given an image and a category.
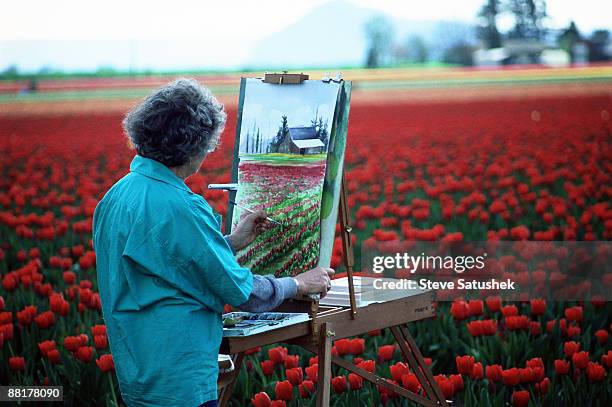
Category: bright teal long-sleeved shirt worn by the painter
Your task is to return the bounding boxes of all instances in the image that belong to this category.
[93,156,253,407]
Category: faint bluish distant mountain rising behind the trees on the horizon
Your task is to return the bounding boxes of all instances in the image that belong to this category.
[244,0,475,69]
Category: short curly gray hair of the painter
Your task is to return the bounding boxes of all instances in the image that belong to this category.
[123,78,227,167]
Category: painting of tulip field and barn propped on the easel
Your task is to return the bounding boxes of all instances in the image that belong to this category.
[230,79,350,276]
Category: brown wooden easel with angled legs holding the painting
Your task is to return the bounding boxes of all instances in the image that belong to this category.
[219,73,448,407]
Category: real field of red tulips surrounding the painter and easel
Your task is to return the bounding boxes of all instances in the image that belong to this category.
[0,66,612,407]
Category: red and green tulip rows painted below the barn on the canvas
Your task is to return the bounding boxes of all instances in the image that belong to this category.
[234,154,327,276]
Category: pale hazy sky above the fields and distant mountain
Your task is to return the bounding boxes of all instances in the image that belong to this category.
[0,0,612,70]
